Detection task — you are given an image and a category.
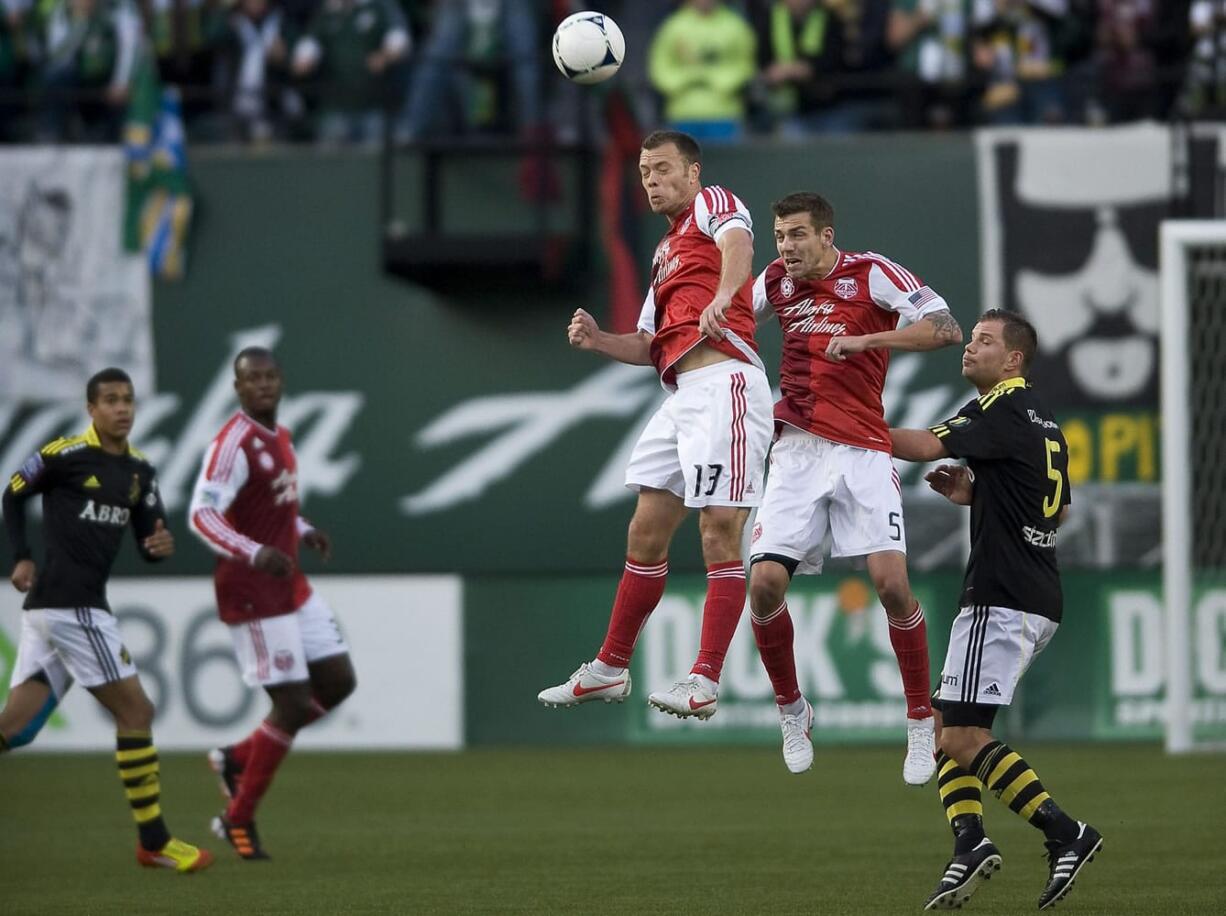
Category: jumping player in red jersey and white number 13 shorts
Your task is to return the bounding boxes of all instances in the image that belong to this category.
[538,131,769,719]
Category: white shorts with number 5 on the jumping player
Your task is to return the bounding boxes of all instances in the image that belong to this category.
[749,426,907,574]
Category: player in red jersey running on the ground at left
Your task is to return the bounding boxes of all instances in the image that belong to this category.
[188,347,356,860]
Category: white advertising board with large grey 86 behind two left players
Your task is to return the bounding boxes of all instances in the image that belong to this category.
[0,576,463,753]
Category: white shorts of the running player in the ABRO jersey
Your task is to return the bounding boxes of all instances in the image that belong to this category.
[9,607,136,699]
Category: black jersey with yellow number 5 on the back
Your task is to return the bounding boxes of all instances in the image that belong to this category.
[932,378,1072,620]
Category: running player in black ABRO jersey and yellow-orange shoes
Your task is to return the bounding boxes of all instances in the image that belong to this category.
[0,369,212,872]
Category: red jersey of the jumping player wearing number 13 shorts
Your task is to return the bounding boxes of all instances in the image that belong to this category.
[639,185,763,390]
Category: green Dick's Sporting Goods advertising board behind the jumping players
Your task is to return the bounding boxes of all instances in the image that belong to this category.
[465,573,1226,747]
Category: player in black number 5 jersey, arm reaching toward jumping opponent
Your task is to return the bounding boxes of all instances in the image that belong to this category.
[890,309,1102,910]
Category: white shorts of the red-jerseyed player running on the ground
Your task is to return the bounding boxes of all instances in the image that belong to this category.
[229,592,349,687]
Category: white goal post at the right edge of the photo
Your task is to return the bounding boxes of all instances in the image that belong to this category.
[1159,219,1226,753]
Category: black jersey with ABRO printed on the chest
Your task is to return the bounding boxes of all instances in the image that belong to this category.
[4,426,166,611]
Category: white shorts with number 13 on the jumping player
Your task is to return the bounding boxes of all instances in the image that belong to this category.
[625,359,775,509]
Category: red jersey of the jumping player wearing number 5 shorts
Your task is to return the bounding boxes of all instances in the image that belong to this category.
[754,251,949,452]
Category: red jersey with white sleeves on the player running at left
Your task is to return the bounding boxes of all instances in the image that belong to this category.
[188,411,310,623]
